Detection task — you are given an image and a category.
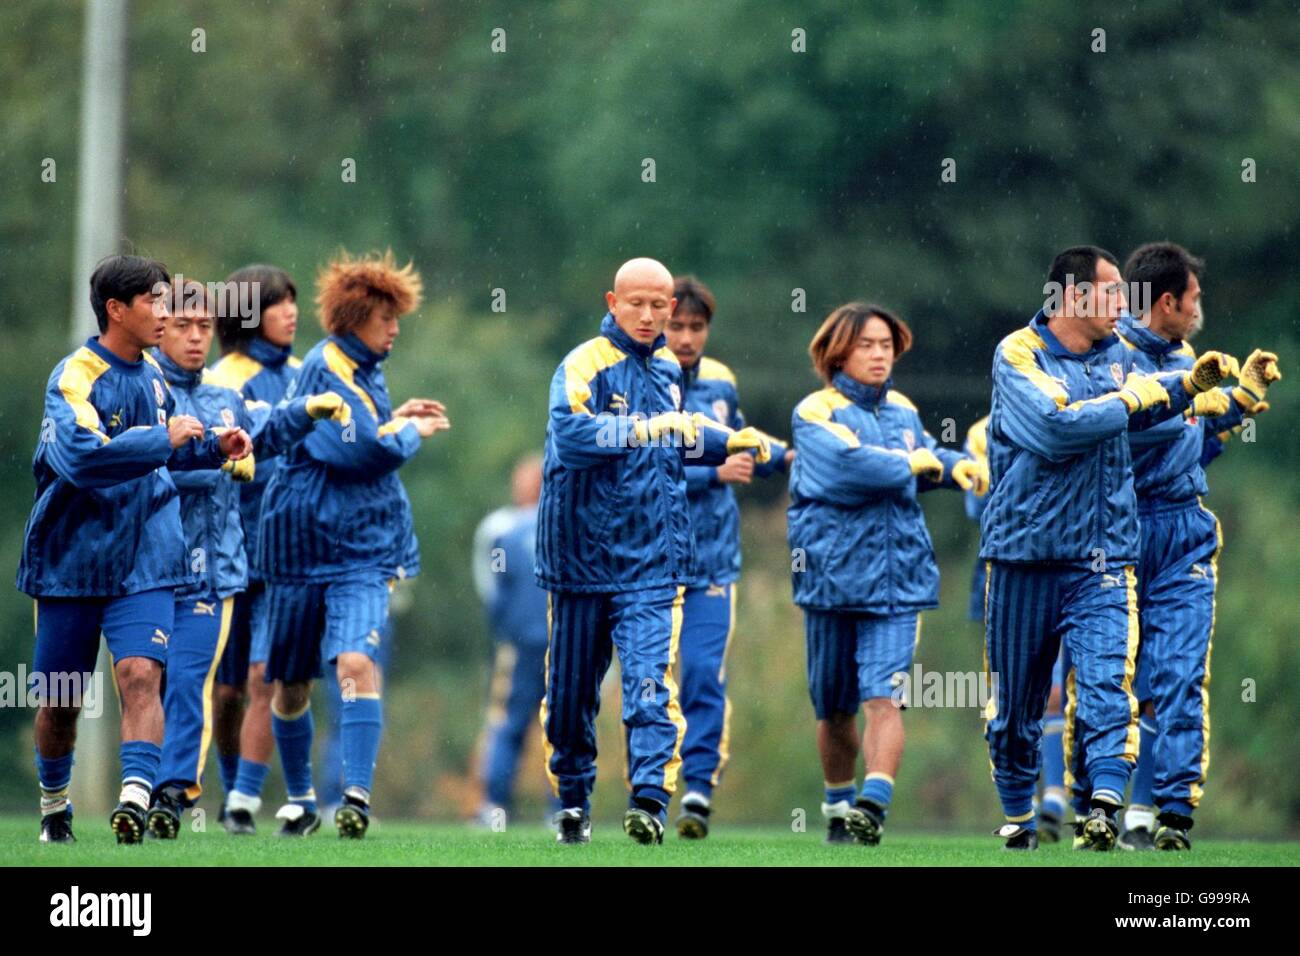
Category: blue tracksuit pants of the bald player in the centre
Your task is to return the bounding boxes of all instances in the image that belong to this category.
[541,587,686,809]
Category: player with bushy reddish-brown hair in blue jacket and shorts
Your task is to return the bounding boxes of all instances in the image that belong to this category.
[259,251,451,839]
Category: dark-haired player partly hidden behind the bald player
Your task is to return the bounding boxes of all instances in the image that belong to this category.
[664,276,794,839]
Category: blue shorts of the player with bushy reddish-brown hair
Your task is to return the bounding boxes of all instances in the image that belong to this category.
[267,578,390,684]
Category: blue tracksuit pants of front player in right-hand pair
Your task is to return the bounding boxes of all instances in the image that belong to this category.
[984,561,1138,823]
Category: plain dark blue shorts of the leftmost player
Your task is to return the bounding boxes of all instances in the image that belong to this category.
[31,588,176,682]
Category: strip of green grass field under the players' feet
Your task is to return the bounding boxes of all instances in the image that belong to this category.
[0,817,1300,868]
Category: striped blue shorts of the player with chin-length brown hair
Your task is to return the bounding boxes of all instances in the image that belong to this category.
[803,607,920,721]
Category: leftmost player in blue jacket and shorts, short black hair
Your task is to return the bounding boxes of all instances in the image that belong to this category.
[18,256,251,843]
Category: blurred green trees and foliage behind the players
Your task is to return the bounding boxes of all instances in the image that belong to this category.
[0,0,1300,835]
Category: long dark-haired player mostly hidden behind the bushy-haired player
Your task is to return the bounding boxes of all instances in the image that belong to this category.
[211,265,302,836]
